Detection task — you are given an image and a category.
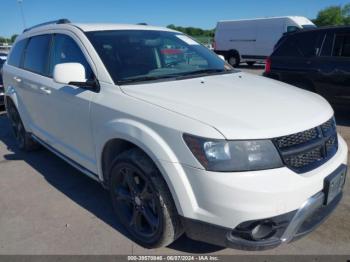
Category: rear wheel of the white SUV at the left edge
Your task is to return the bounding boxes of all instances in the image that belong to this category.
[6,100,40,152]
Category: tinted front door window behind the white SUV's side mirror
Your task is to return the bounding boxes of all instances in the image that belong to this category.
[50,34,94,79]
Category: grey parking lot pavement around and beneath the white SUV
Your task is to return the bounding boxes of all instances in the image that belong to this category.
[0,66,350,255]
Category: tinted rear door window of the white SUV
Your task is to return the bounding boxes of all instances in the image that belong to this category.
[23,35,51,75]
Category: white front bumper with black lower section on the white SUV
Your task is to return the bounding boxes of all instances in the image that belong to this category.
[162,136,348,249]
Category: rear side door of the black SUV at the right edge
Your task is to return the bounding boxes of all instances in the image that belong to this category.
[315,29,350,104]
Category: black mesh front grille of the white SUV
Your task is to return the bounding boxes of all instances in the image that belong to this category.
[273,118,338,173]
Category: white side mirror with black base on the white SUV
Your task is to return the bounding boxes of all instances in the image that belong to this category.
[53,63,99,91]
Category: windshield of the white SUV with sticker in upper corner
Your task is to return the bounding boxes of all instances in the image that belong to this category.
[87,30,234,84]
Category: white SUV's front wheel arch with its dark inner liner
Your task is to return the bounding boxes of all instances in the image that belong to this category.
[97,119,196,217]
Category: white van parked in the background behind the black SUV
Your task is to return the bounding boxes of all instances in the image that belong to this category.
[214,16,316,66]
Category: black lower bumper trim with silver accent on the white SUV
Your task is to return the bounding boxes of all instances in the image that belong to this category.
[182,179,342,250]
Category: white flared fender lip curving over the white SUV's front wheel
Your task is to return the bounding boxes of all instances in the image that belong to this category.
[96,119,198,215]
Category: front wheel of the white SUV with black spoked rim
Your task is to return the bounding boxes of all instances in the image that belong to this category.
[110,148,183,248]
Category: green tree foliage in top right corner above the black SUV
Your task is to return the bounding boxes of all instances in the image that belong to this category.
[314,4,350,26]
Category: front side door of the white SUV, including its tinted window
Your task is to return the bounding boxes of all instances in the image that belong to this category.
[45,34,96,173]
